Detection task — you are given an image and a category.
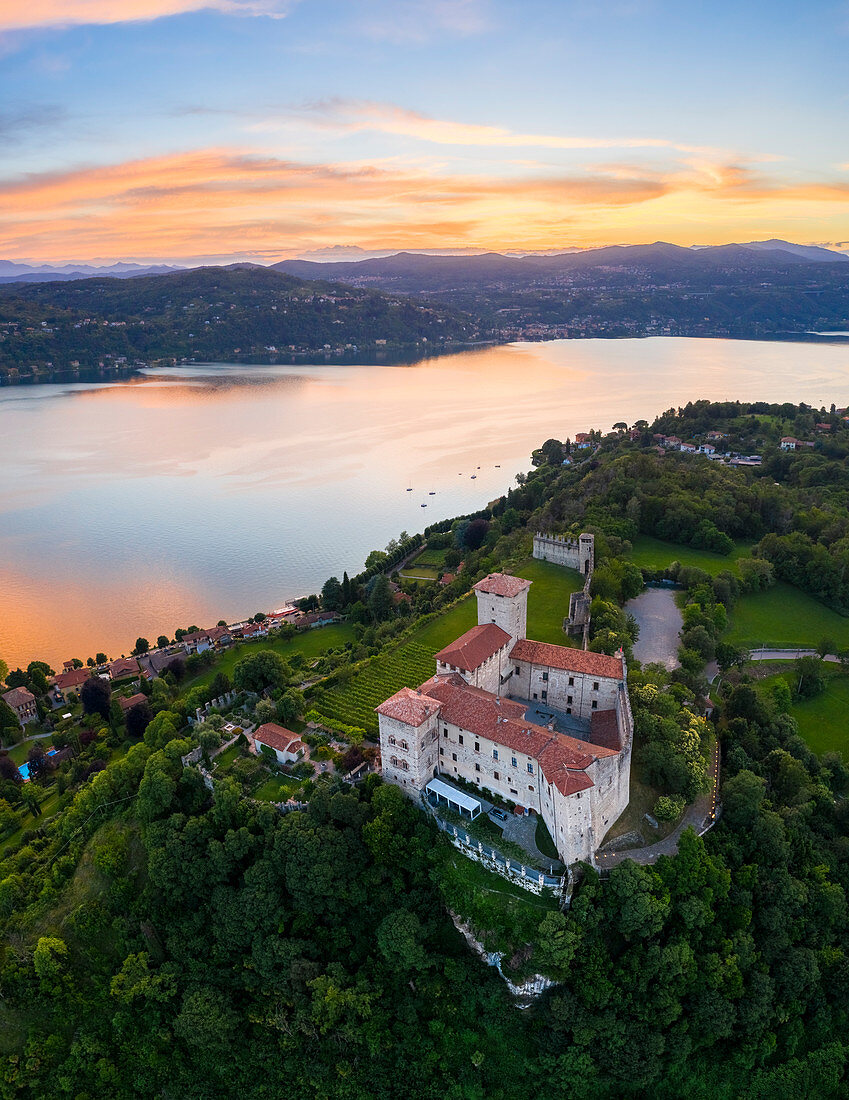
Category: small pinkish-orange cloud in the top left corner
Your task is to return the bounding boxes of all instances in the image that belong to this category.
[0,0,293,31]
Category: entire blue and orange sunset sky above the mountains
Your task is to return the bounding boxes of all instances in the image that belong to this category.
[0,0,849,264]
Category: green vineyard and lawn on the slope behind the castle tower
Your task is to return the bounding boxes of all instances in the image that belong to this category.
[315,560,582,734]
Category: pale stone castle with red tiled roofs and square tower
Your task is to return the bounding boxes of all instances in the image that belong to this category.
[377,567,633,866]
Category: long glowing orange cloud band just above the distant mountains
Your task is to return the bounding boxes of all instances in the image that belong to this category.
[0,149,849,262]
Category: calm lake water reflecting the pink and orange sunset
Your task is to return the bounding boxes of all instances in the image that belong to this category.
[0,339,849,667]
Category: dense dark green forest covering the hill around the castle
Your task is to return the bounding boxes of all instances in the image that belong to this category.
[0,405,849,1100]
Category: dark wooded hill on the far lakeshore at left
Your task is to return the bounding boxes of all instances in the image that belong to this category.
[0,264,476,375]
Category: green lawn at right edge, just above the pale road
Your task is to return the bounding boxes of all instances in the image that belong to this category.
[725,582,849,649]
